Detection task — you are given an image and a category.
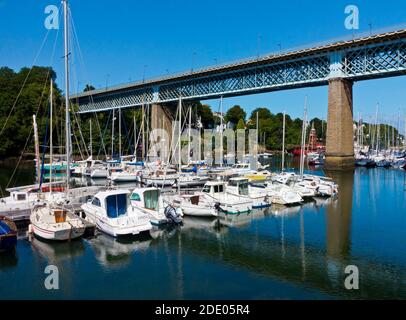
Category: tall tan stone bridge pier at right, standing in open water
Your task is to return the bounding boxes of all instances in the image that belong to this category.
[325,78,354,170]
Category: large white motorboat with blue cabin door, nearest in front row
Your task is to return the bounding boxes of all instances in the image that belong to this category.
[81,189,152,237]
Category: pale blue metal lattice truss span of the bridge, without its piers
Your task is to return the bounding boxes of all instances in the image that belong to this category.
[71,29,406,113]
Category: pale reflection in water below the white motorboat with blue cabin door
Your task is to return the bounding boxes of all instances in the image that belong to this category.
[88,233,152,269]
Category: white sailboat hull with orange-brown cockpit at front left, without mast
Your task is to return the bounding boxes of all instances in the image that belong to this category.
[30,201,86,241]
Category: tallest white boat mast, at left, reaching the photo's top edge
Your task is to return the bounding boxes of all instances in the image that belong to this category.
[63,0,70,191]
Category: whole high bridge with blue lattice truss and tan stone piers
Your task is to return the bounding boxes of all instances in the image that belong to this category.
[71,29,406,169]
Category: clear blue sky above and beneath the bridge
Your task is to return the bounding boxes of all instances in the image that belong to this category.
[0,0,406,125]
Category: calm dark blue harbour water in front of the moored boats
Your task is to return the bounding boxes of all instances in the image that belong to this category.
[0,160,406,299]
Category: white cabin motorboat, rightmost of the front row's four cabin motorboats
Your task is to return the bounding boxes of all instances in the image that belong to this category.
[226,177,272,209]
